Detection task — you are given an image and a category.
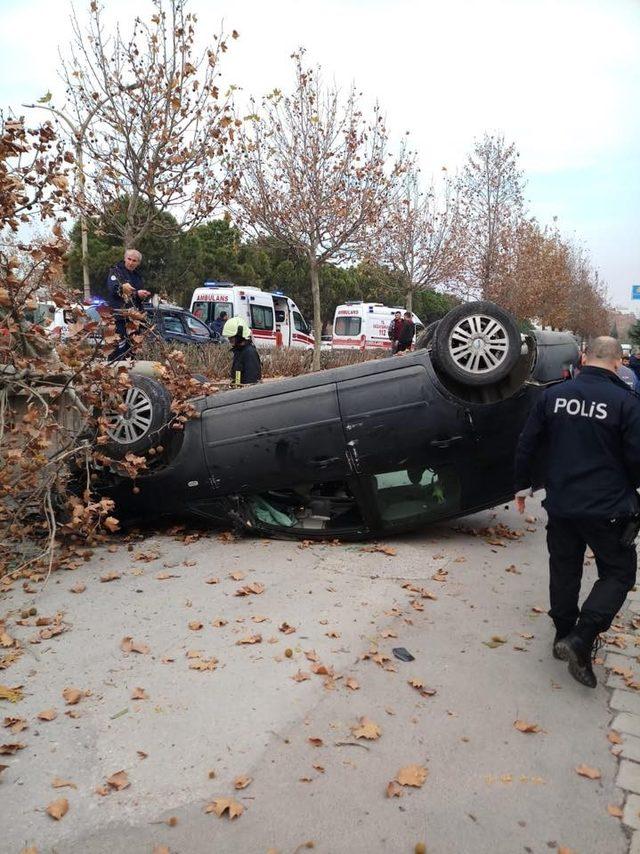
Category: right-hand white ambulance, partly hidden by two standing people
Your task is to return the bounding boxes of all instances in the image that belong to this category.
[331,300,424,350]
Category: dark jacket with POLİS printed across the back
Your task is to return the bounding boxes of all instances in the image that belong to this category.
[515,366,640,519]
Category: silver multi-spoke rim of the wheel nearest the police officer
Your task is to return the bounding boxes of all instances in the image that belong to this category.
[449,314,509,374]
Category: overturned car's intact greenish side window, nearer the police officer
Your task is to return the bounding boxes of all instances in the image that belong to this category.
[374,465,461,526]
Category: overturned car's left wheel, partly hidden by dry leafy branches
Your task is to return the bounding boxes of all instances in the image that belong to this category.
[103,374,171,459]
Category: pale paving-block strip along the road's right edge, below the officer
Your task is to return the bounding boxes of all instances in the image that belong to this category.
[604,589,640,854]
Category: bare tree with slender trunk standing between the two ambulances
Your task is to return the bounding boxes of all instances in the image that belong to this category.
[229,51,398,370]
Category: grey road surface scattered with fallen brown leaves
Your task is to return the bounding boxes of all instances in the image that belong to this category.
[0,494,640,854]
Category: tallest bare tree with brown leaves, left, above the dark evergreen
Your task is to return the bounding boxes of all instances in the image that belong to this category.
[57,0,237,247]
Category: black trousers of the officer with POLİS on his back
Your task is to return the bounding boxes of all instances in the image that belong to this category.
[547,516,636,636]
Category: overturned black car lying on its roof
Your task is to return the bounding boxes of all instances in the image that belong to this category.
[97,302,578,539]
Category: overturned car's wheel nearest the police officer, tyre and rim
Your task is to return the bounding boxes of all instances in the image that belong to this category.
[432,301,521,386]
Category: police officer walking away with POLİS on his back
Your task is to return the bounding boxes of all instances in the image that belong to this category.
[515,337,640,688]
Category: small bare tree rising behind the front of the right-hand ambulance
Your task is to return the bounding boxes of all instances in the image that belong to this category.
[379,157,463,311]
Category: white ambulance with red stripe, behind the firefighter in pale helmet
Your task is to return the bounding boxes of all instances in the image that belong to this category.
[190,282,313,350]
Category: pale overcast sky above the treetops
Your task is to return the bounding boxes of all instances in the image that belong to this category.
[0,0,640,307]
